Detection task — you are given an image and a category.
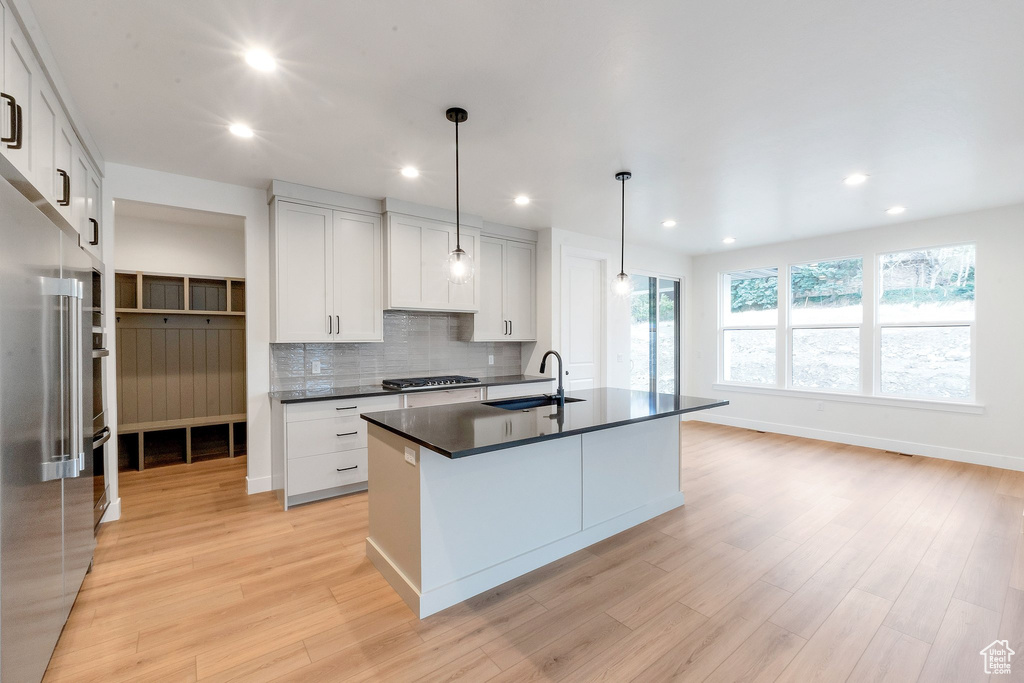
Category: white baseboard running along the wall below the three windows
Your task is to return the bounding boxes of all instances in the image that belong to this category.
[691,413,1024,471]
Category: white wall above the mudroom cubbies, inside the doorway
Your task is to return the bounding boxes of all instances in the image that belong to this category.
[114,214,246,278]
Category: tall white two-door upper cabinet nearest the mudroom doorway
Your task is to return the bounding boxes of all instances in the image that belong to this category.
[273,201,383,342]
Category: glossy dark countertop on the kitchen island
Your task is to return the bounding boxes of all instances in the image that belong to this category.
[362,388,729,458]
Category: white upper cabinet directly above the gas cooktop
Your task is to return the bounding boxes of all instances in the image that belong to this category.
[385,213,480,312]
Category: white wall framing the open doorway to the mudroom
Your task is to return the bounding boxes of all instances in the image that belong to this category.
[103,163,270,519]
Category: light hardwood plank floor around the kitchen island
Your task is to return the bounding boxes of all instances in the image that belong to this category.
[46,423,1024,683]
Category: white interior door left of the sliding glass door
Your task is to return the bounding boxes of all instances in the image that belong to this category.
[561,256,604,390]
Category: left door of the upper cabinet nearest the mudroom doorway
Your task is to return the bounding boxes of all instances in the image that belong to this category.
[274,202,335,342]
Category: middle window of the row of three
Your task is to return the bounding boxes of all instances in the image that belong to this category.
[790,258,864,391]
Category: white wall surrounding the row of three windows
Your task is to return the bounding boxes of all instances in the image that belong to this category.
[686,205,1024,470]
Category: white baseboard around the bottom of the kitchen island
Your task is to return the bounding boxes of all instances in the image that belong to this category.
[367,492,684,618]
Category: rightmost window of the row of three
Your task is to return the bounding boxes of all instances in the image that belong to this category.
[878,245,975,399]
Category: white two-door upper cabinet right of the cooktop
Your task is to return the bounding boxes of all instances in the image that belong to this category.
[473,237,537,341]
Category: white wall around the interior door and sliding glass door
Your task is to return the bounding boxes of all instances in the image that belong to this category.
[523,228,690,388]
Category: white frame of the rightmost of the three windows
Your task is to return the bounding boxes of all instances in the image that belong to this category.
[871,241,978,404]
